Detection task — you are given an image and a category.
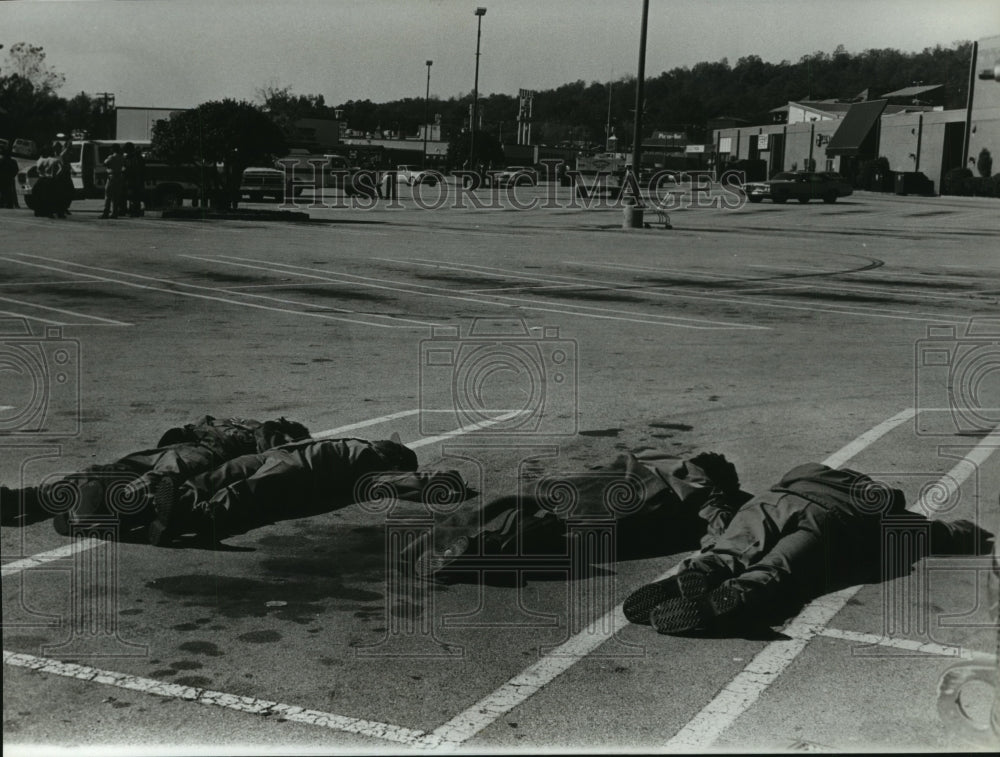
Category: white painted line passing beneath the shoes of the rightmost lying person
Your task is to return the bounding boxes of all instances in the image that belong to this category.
[420,409,915,749]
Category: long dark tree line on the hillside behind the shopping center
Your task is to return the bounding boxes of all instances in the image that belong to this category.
[331,42,972,145]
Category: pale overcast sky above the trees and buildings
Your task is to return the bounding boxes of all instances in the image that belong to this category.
[0,0,1000,107]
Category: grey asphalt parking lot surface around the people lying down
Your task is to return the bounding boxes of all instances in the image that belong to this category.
[0,182,1000,752]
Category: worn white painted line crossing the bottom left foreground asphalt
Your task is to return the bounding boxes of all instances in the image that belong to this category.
[3,649,425,744]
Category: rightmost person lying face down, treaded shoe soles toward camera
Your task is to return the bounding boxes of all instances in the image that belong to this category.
[624,463,992,633]
